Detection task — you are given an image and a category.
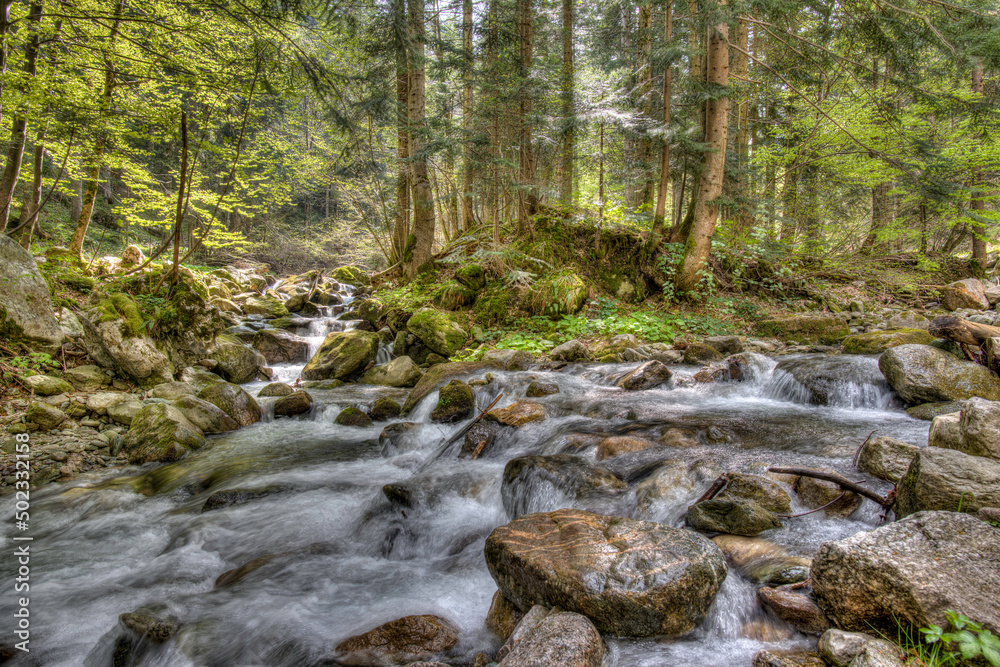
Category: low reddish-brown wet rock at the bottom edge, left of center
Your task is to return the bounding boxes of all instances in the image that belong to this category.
[336,615,458,666]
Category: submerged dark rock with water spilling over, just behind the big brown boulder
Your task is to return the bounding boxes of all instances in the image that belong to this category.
[500,454,628,518]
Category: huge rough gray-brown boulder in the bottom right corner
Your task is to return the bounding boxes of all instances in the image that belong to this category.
[812,512,1000,634]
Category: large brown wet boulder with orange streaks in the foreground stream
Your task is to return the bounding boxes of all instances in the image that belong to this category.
[485,509,727,640]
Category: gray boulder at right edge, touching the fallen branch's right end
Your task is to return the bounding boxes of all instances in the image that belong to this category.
[895,447,1000,520]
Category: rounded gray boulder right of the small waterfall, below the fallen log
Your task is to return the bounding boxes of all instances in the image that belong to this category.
[878,345,1000,404]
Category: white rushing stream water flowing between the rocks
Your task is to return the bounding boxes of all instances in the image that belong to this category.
[0,318,928,667]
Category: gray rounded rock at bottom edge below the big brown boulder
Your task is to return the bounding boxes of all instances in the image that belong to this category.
[498,612,604,667]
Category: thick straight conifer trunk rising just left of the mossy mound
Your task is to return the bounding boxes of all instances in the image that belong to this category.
[404,0,434,280]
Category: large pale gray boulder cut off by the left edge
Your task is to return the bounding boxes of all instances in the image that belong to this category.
[0,234,64,354]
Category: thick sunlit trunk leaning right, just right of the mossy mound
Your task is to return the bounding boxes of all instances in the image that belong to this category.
[676,0,729,293]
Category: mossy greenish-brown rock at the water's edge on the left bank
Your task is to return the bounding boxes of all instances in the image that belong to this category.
[123,403,205,463]
